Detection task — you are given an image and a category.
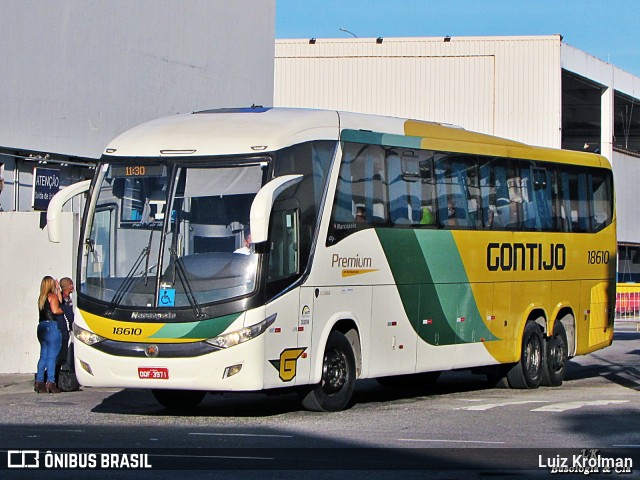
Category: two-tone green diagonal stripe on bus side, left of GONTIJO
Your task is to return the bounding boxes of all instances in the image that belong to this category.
[376,229,497,345]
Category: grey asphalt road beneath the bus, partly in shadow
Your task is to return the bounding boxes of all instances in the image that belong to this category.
[0,327,640,479]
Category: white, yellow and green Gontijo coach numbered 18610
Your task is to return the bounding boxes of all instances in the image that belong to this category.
[49,107,616,411]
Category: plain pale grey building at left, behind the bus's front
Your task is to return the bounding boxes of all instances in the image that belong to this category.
[0,0,275,372]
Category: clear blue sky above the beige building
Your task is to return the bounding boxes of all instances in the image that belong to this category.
[276,0,640,77]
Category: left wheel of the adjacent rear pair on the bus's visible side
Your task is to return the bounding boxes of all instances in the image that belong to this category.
[507,322,544,389]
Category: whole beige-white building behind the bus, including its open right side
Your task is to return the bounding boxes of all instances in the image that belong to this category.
[274,35,640,281]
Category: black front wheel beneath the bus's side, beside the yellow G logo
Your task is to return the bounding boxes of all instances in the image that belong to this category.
[300,330,356,412]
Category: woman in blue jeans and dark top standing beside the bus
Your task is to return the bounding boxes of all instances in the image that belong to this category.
[34,275,64,393]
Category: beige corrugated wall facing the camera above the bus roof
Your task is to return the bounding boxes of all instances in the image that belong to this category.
[274,35,561,148]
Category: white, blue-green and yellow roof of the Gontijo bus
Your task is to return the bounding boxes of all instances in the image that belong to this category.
[105,107,611,168]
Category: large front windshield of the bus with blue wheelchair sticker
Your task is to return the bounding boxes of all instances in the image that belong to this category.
[80,158,268,310]
